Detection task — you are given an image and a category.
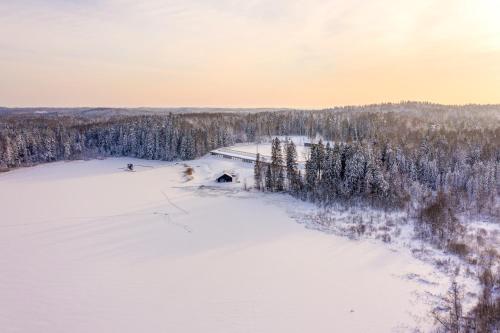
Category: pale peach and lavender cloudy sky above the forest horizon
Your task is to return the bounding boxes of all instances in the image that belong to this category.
[0,0,500,108]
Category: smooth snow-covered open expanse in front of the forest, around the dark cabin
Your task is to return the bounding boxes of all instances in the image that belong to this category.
[0,157,474,333]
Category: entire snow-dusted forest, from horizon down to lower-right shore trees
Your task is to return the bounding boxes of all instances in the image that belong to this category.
[0,102,500,332]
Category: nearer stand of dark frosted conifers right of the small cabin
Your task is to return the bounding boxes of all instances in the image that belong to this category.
[254,138,500,223]
